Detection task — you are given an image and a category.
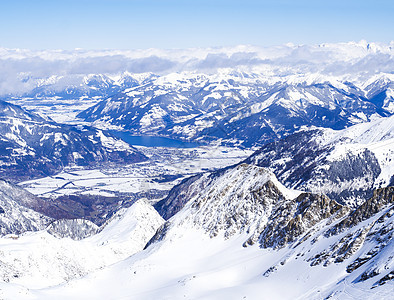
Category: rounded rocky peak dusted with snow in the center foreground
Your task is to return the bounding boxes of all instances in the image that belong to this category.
[152,164,299,241]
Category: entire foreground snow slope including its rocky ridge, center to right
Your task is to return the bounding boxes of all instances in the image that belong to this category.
[3,165,394,299]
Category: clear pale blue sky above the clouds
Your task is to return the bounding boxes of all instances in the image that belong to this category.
[0,0,394,49]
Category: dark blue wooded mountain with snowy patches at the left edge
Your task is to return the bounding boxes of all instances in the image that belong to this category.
[0,101,146,181]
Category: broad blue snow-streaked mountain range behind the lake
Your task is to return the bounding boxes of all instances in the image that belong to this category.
[78,71,392,146]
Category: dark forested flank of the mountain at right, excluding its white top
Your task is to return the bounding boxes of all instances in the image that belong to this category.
[245,130,381,203]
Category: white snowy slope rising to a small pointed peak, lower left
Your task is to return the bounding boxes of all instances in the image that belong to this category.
[0,200,163,288]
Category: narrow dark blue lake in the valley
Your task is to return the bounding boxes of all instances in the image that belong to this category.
[110,131,201,148]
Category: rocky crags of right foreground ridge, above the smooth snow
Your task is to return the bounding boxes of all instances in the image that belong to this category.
[146,164,394,289]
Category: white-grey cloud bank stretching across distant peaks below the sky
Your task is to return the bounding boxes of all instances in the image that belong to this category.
[0,41,394,95]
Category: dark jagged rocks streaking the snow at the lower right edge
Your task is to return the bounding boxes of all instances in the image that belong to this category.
[308,187,394,270]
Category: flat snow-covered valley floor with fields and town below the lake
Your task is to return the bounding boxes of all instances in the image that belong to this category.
[19,146,253,200]
